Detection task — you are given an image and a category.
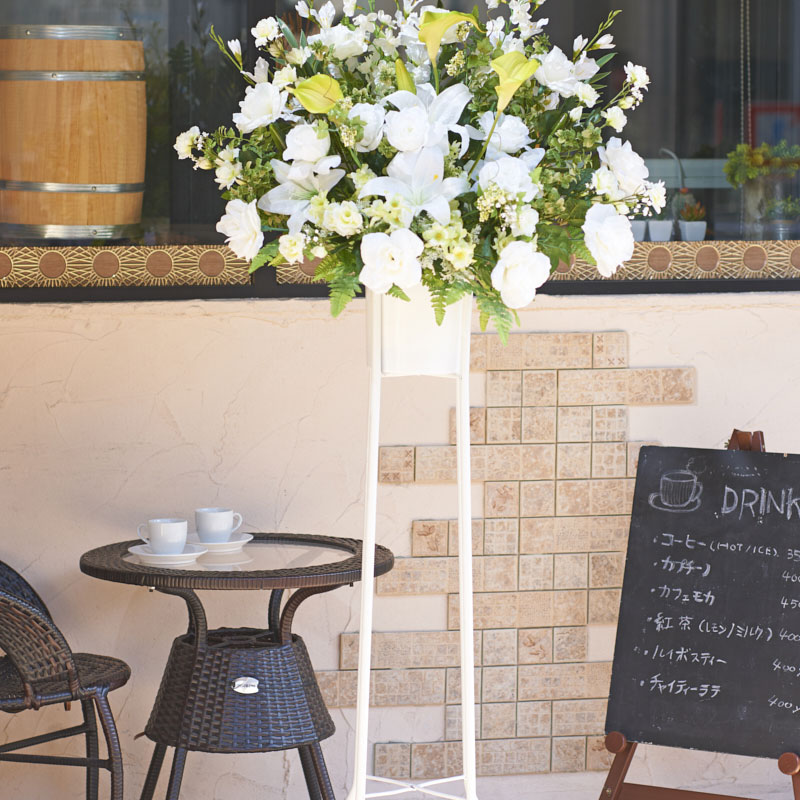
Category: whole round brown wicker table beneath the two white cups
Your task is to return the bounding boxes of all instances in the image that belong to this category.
[81,533,394,800]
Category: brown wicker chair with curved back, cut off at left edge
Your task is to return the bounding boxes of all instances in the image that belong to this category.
[0,561,130,800]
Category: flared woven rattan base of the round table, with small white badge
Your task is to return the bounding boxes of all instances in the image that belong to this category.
[145,628,334,753]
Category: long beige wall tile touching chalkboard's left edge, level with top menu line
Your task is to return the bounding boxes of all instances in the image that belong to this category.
[520,516,631,554]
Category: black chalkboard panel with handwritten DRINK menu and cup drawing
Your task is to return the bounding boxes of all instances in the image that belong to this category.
[606,447,800,758]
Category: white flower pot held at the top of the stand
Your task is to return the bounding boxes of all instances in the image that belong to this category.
[367,284,472,375]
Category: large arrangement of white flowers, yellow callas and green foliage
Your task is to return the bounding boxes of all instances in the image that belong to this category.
[175,0,665,338]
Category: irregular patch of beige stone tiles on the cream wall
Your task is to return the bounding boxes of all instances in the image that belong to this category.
[318,332,695,779]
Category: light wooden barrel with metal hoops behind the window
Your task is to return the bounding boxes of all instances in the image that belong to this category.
[0,25,147,240]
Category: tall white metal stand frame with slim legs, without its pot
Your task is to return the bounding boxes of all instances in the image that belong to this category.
[347,298,478,800]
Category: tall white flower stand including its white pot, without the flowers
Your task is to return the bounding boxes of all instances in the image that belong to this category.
[347,286,478,800]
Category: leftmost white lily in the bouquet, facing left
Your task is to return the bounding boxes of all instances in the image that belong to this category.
[258,156,345,235]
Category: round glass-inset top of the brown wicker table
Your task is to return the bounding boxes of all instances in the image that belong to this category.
[80,533,394,589]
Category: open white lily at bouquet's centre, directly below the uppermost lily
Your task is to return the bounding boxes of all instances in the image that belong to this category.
[358,147,469,225]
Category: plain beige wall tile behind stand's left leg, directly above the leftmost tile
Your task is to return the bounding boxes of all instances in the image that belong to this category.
[339,625,460,669]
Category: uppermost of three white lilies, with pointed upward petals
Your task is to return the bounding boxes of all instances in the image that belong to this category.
[386,83,472,156]
